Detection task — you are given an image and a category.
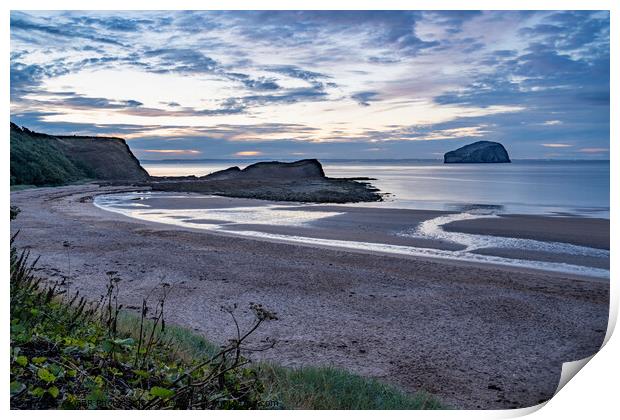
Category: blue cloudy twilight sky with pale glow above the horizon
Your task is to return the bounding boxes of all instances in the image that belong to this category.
[10,11,610,160]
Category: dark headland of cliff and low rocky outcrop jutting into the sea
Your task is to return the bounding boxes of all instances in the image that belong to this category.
[11,123,382,203]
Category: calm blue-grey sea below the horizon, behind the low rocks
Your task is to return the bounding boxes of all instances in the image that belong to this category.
[143,160,609,218]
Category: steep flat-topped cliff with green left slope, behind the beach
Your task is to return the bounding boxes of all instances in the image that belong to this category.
[10,123,149,185]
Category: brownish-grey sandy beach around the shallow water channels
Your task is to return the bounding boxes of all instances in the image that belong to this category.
[11,184,609,408]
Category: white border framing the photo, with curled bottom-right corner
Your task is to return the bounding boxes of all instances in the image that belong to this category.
[0,0,620,419]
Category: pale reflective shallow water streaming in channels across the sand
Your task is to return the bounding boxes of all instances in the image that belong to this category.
[95,192,609,279]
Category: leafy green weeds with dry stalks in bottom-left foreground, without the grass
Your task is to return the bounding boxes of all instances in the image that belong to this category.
[10,237,275,409]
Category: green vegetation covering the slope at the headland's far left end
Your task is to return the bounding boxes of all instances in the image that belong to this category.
[11,124,87,186]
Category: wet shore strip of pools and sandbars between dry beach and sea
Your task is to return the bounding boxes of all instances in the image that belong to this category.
[94,188,609,279]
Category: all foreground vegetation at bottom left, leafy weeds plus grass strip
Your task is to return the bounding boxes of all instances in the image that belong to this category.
[10,207,442,409]
